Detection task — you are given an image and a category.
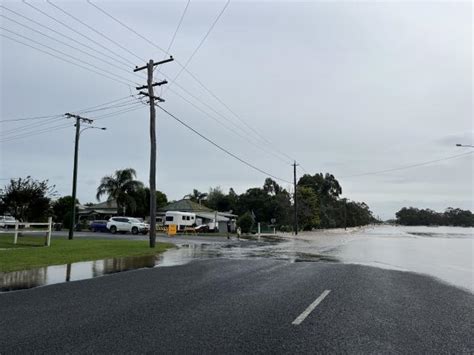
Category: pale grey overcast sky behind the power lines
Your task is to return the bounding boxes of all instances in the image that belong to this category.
[0,1,474,218]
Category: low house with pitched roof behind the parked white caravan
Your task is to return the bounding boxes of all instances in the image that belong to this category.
[156,199,237,233]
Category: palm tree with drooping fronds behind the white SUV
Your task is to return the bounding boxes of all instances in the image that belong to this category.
[96,168,143,215]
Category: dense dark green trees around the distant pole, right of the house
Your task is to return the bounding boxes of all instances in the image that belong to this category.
[188,173,377,232]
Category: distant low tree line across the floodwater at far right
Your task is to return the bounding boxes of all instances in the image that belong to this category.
[395,207,474,227]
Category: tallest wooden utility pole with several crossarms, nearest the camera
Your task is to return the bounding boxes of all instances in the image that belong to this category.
[133,57,173,248]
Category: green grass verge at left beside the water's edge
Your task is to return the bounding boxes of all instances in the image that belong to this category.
[0,235,173,272]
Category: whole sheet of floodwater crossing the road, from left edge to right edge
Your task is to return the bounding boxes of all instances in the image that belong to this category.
[0,226,474,292]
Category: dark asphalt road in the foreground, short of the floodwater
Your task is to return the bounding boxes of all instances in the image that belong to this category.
[0,259,474,354]
